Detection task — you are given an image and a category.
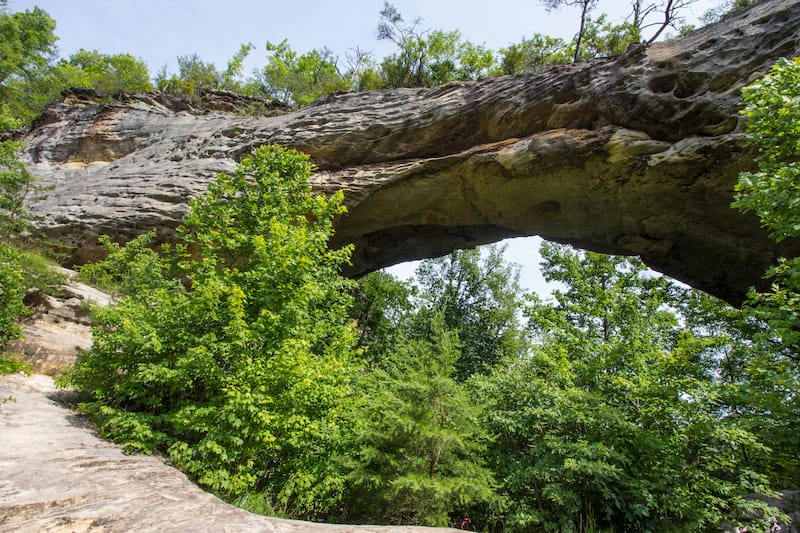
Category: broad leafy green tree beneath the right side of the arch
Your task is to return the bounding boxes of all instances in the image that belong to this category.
[477,244,774,531]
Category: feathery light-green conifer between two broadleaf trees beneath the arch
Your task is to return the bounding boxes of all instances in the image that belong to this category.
[344,319,494,526]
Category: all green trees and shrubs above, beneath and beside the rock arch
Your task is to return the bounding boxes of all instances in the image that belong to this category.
[0,0,800,532]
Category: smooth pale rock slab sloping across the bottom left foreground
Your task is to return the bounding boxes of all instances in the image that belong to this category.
[0,374,455,533]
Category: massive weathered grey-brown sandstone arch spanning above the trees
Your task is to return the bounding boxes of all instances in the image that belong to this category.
[21,0,800,302]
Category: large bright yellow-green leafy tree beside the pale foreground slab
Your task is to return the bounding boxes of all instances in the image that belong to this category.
[66,146,355,517]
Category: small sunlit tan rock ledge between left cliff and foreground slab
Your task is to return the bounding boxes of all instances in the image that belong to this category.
[9,269,111,375]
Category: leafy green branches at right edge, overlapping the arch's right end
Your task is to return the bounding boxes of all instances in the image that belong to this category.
[733,58,800,486]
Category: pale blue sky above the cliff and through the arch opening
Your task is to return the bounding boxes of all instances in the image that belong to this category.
[8,0,718,293]
